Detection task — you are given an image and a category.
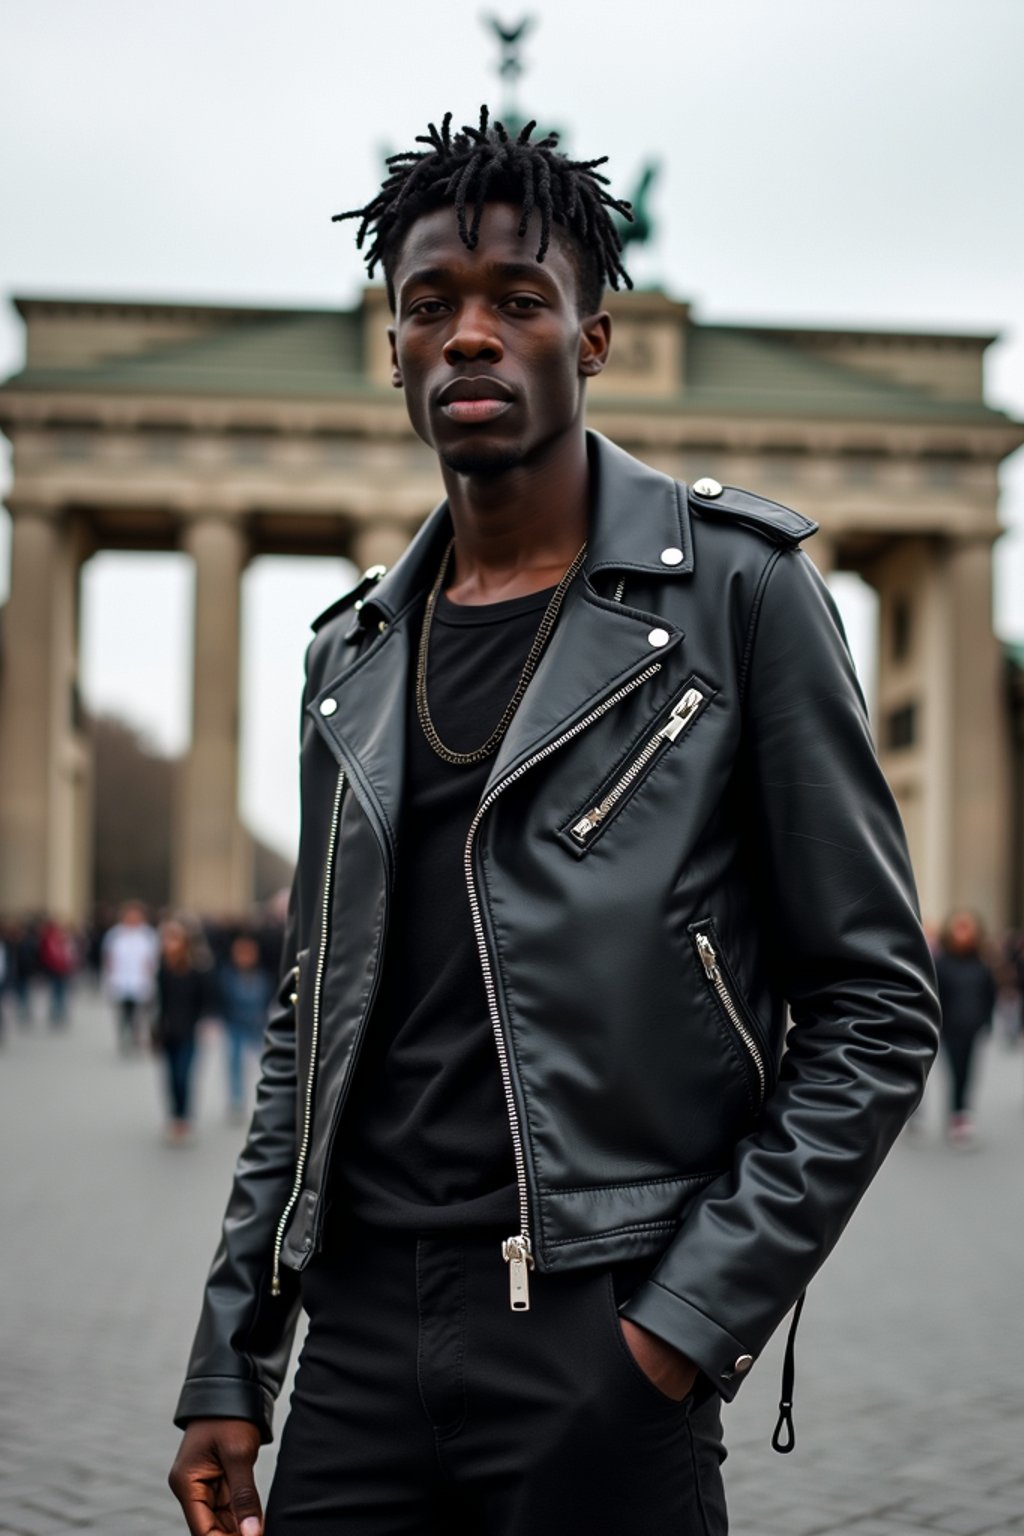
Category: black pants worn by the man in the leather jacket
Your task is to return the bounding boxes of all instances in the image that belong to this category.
[267,1217,728,1536]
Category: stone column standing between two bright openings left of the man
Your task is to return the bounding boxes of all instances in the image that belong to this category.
[172,516,252,915]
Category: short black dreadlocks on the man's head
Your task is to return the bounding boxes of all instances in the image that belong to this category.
[333,106,633,315]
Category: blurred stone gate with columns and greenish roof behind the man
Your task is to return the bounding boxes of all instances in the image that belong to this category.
[0,287,1024,925]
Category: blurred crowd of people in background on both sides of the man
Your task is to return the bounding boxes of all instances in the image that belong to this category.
[0,892,1024,1147]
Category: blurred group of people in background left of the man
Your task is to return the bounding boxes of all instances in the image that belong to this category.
[0,892,287,1144]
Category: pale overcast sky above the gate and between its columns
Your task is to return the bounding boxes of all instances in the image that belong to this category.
[0,0,1024,851]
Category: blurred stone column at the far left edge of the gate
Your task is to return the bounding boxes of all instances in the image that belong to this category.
[0,507,88,919]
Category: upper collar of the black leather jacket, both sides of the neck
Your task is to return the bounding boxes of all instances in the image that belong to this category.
[358,432,694,627]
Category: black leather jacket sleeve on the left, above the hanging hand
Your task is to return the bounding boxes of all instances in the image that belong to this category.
[175,709,307,1442]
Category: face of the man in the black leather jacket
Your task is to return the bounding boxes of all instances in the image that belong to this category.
[388,203,611,475]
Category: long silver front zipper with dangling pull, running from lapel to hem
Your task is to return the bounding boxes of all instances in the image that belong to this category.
[464,662,662,1312]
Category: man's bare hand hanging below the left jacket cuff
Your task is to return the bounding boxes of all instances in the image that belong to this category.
[167,1419,263,1536]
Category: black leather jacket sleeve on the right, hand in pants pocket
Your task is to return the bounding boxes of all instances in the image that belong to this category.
[619,550,940,1399]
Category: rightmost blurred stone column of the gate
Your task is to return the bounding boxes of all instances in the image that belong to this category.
[946,536,1012,929]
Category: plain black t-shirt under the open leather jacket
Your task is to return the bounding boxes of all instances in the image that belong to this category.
[332,587,554,1232]
